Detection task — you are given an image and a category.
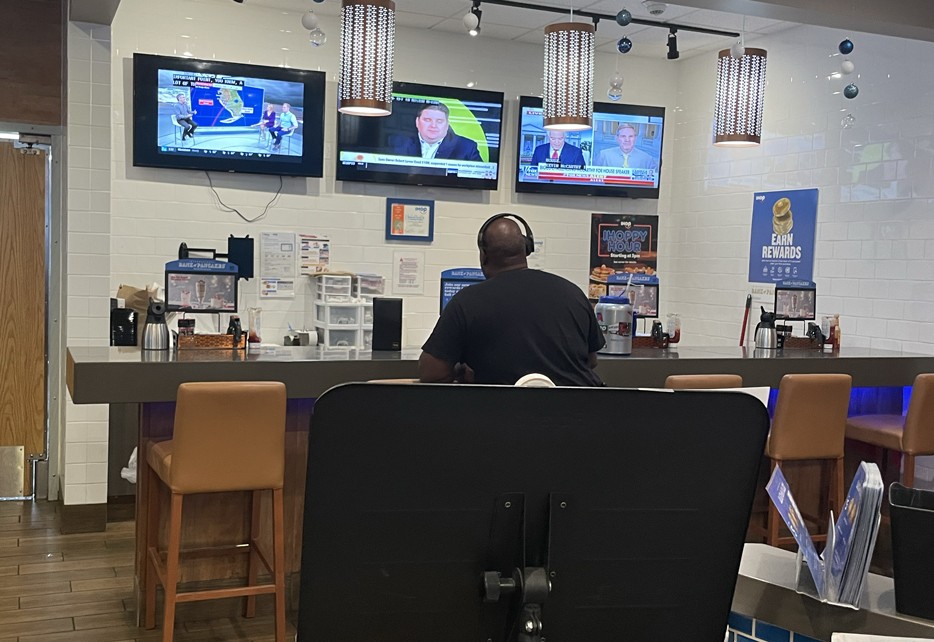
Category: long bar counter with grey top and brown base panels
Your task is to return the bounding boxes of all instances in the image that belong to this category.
[63,346,934,632]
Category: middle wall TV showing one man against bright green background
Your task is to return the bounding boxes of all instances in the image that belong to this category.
[337,82,503,190]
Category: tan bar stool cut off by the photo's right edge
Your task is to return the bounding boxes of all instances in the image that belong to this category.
[846,374,934,487]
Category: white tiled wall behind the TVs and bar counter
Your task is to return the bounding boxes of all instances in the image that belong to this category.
[56,0,934,503]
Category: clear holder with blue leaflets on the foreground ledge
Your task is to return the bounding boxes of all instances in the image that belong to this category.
[766,462,883,610]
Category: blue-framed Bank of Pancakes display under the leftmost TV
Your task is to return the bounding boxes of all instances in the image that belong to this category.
[165,259,238,312]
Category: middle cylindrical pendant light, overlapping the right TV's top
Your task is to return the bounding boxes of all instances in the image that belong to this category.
[542,22,595,131]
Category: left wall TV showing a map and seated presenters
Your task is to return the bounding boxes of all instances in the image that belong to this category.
[133,54,324,176]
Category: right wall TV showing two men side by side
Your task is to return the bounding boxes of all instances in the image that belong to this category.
[516,96,665,198]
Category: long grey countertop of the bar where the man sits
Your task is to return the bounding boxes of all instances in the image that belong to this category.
[67,346,934,403]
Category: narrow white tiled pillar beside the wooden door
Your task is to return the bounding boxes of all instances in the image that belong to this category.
[65,22,111,504]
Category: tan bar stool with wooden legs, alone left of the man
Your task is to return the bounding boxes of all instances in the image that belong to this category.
[145,381,286,642]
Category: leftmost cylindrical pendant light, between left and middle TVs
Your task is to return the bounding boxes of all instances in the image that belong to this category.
[337,0,396,116]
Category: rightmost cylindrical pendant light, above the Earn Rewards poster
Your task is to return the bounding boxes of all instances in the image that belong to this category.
[714,47,766,147]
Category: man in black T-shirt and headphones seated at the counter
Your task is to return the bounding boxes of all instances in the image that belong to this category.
[418,214,604,386]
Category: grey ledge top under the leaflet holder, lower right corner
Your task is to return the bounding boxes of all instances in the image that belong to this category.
[733,544,934,640]
